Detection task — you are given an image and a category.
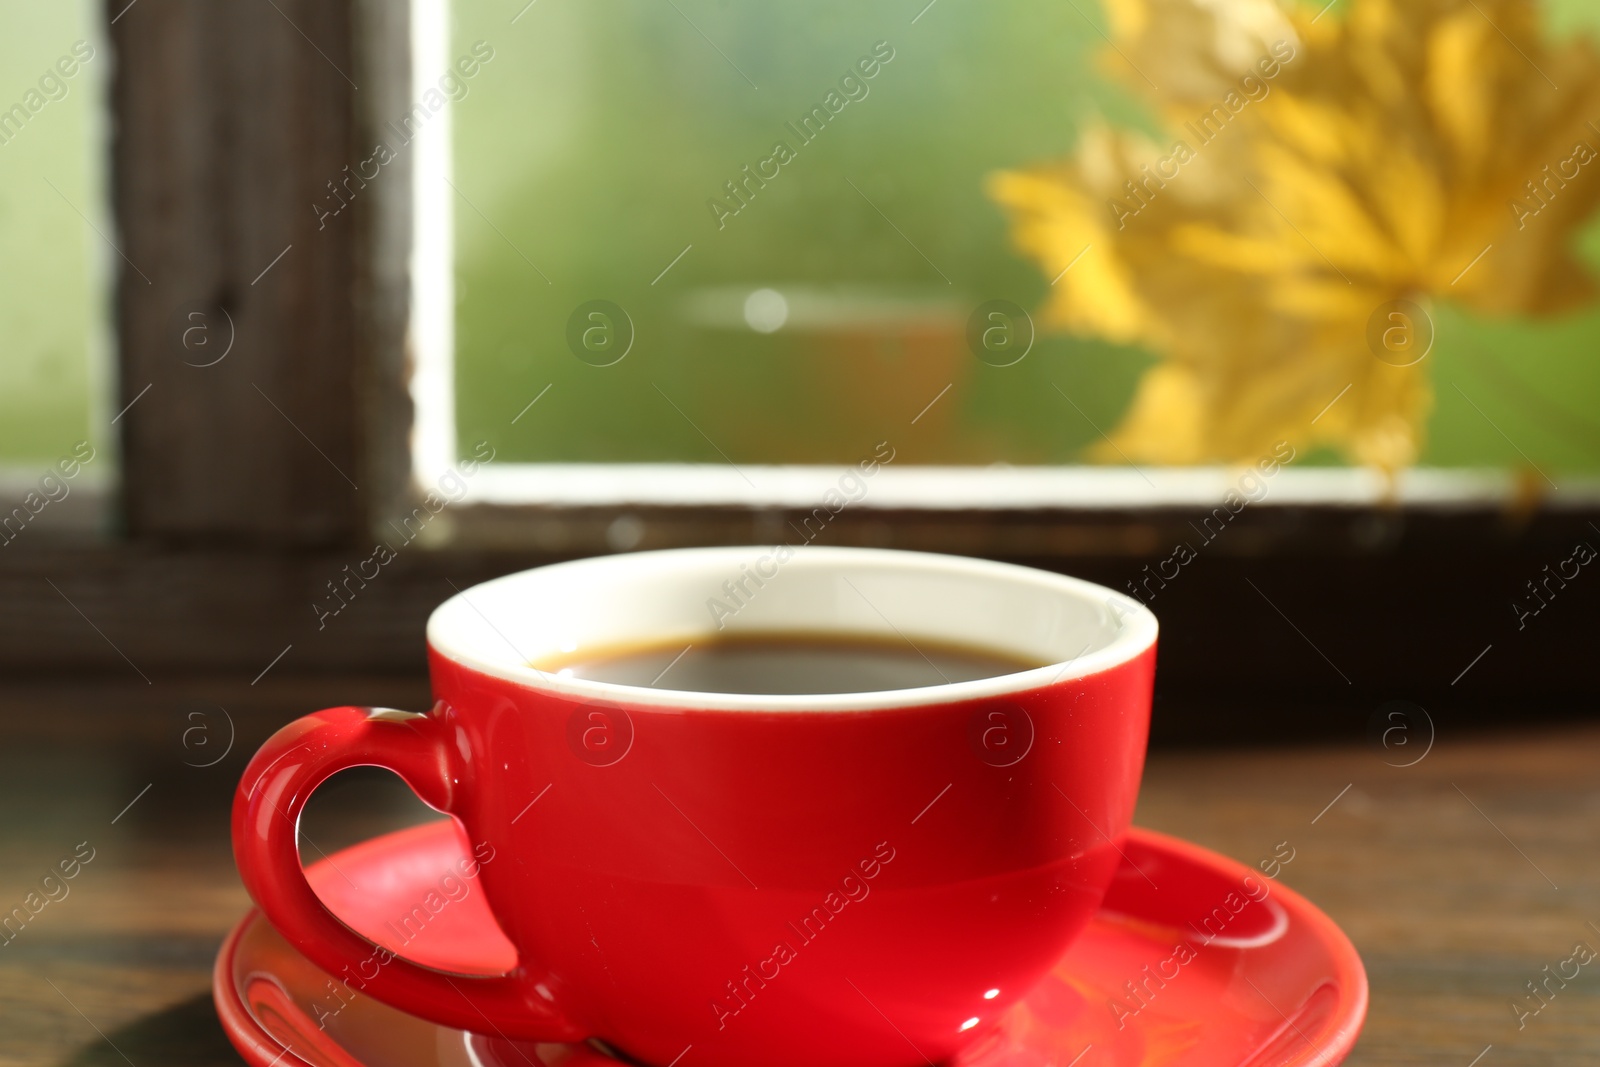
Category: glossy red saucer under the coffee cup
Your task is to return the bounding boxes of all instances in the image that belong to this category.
[213,819,1366,1067]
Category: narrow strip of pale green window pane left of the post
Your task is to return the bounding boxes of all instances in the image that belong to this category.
[0,2,103,464]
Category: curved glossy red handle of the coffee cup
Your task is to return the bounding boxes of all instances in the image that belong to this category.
[234,707,587,1041]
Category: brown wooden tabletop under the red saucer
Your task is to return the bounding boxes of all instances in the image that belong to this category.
[0,673,1600,1067]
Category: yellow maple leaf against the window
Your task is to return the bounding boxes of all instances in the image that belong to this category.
[990,0,1600,472]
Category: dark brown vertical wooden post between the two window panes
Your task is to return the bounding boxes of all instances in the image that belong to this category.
[107,0,410,547]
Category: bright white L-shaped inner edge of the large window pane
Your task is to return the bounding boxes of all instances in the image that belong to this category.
[410,0,1600,510]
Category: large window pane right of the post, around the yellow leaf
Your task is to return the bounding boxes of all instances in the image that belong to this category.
[448,0,1600,475]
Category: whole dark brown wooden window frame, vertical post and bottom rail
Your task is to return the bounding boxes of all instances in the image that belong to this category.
[0,0,1600,737]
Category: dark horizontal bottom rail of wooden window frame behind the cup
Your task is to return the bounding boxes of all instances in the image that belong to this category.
[0,531,1600,729]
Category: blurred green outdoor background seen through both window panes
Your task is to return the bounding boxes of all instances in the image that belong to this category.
[0,0,1600,478]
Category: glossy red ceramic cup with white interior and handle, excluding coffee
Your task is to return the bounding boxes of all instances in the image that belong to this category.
[234,547,1155,1067]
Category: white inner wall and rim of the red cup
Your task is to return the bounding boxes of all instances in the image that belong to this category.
[427,545,1157,712]
